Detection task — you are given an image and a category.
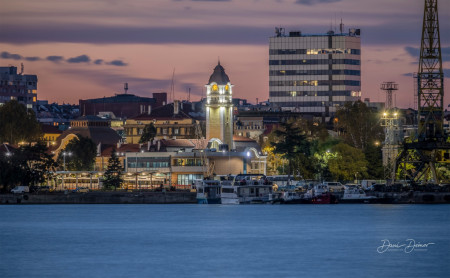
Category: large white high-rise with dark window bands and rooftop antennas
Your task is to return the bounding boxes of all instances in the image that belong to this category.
[269,25,361,119]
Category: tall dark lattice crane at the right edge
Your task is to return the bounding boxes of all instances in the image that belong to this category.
[396,0,450,182]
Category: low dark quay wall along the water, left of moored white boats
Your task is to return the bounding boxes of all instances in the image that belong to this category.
[0,192,196,204]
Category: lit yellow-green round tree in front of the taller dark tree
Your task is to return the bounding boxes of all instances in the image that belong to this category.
[328,143,367,181]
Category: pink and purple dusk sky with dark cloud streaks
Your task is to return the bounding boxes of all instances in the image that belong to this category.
[0,0,450,108]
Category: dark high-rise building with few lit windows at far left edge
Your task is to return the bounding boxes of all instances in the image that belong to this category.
[0,66,37,109]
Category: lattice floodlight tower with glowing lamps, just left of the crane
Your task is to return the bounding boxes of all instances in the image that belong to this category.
[380,82,403,181]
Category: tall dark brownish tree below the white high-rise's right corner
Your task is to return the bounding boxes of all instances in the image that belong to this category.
[335,101,384,150]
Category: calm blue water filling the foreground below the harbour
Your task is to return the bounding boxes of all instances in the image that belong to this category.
[0,204,450,278]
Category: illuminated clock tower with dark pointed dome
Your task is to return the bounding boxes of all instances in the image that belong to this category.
[205,62,234,149]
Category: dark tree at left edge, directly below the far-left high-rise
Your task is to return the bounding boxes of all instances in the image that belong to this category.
[0,100,42,145]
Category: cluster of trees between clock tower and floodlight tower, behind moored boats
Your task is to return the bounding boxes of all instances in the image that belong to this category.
[263,101,384,181]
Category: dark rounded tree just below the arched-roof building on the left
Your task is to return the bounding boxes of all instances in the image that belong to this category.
[58,134,97,171]
